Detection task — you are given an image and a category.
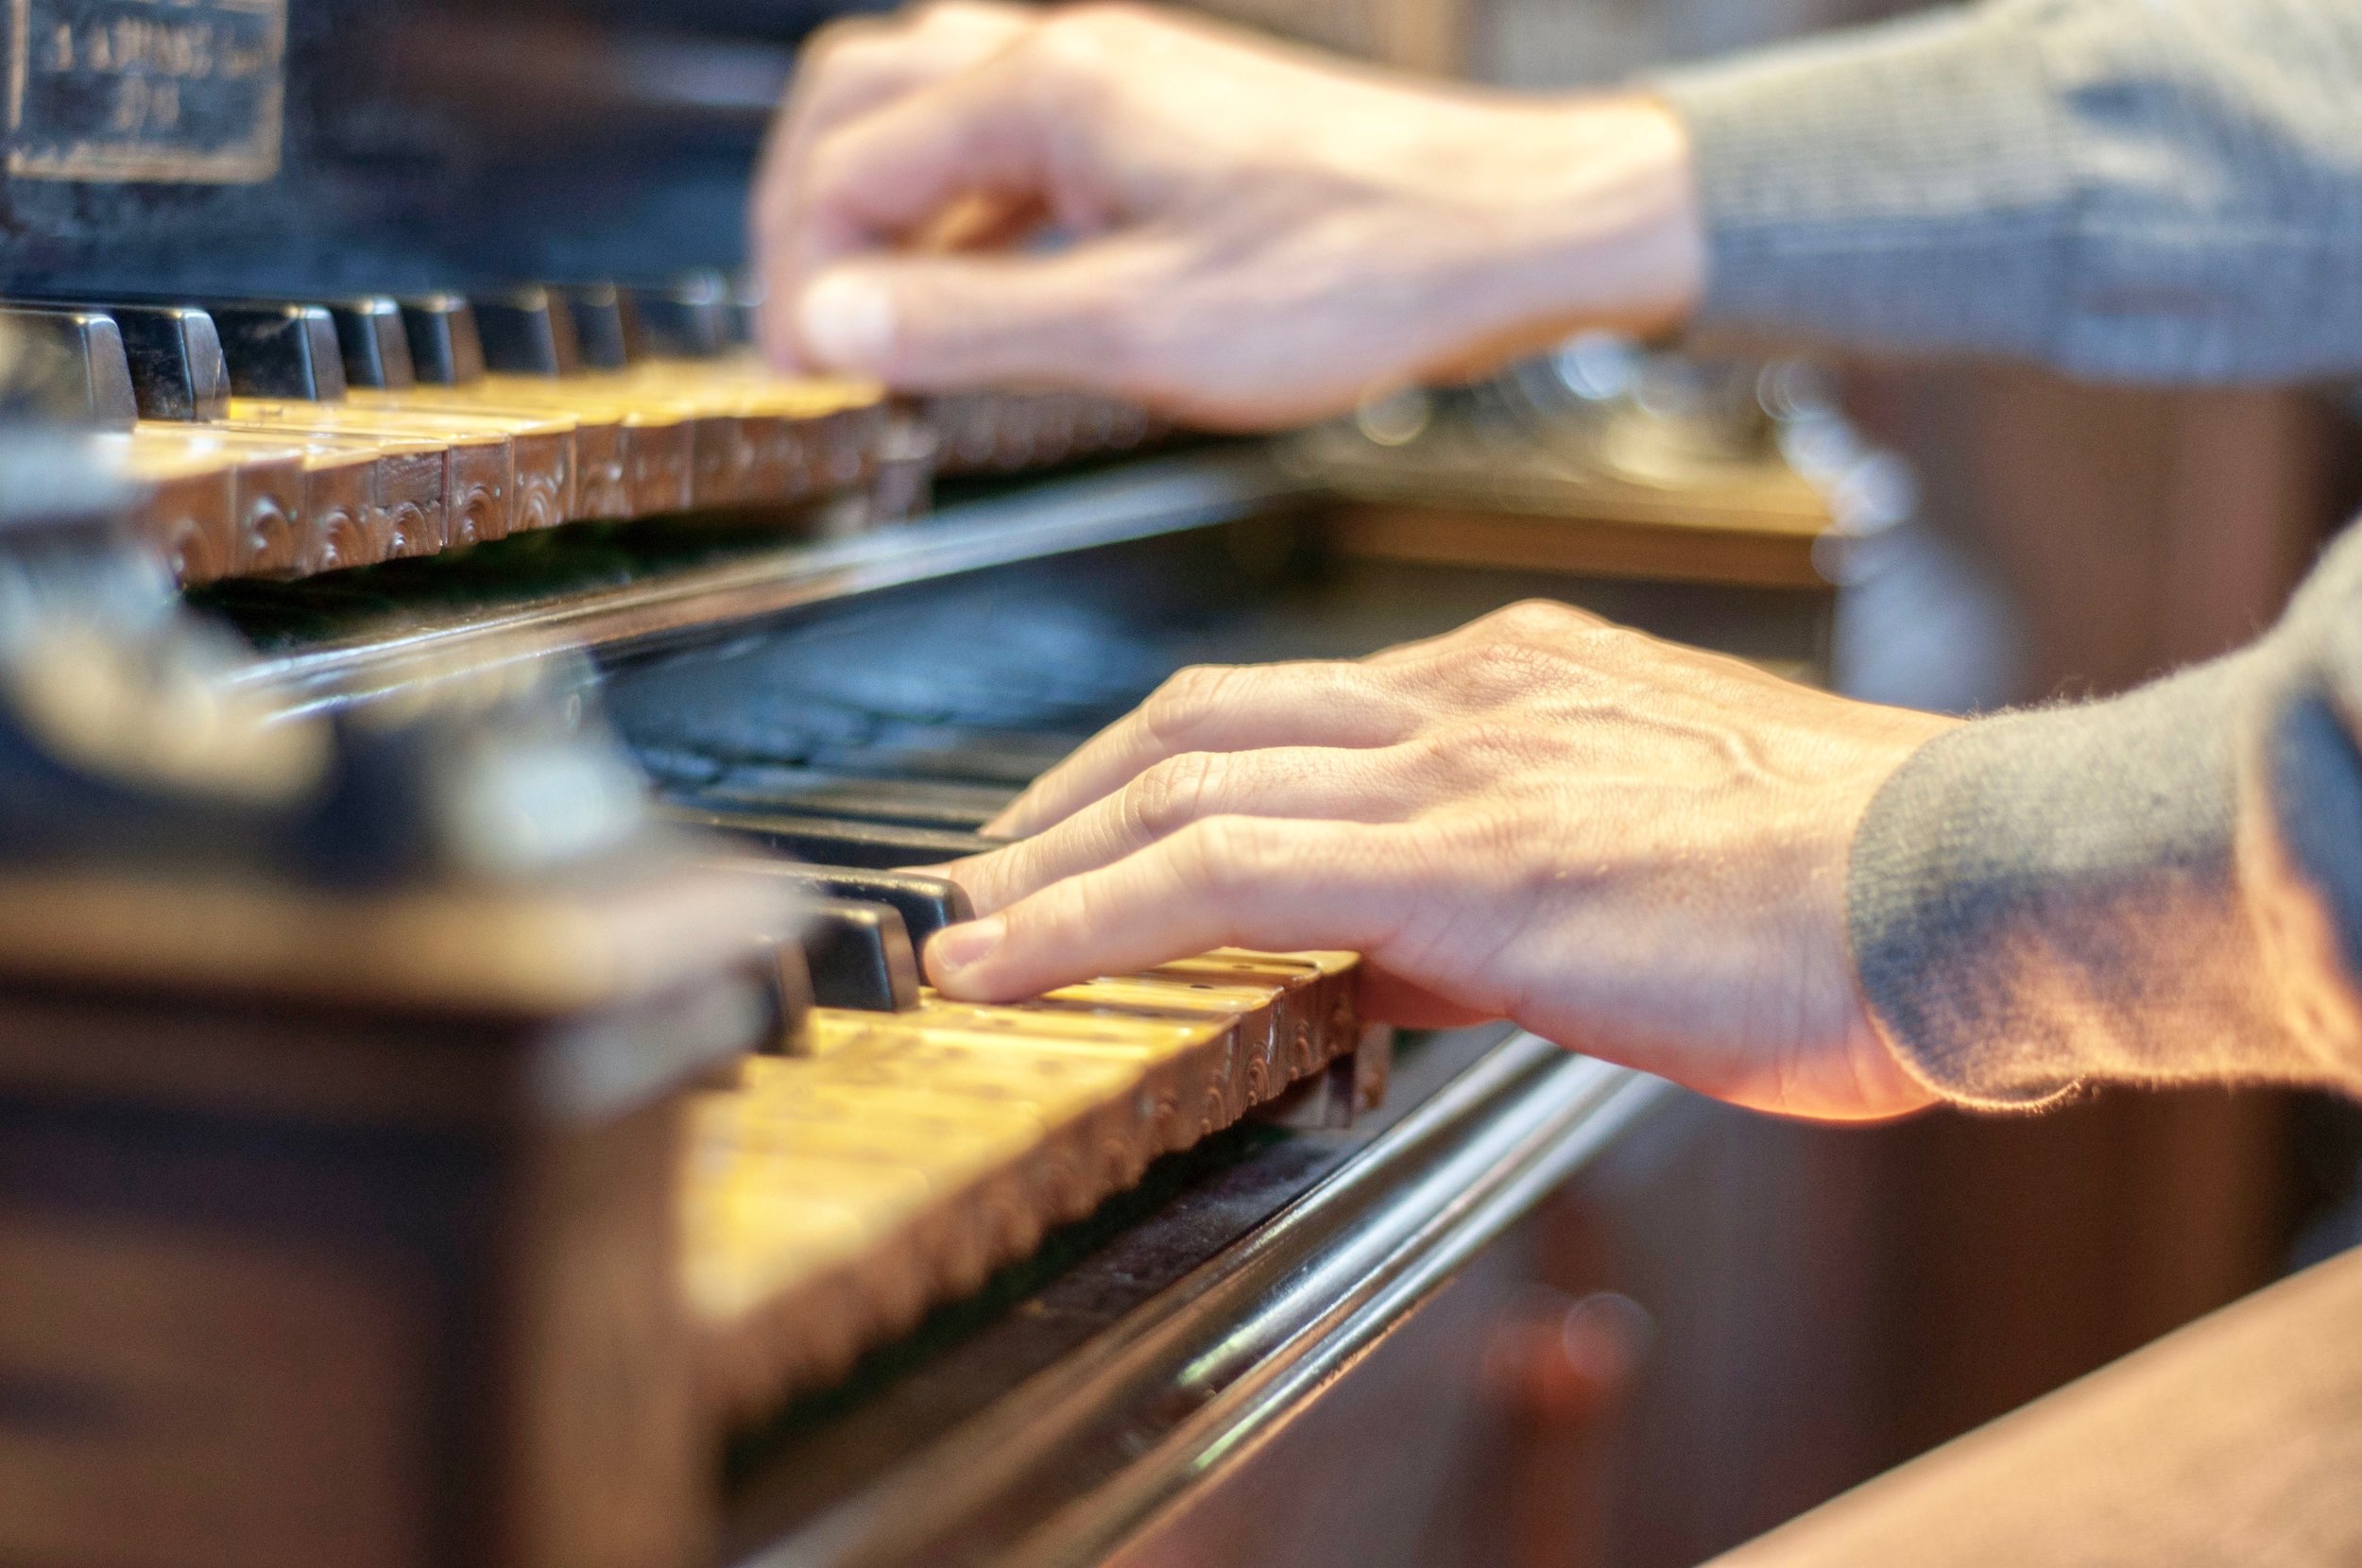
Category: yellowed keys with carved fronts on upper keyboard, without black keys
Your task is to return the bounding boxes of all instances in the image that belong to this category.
[109,347,886,584]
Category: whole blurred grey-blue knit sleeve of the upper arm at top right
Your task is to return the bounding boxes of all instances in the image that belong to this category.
[1652,0,2362,381]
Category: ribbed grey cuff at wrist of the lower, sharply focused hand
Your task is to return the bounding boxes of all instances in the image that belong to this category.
[1847,655,2277,1110]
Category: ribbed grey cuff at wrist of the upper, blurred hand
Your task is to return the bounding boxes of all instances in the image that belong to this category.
[1644,8,2074,354]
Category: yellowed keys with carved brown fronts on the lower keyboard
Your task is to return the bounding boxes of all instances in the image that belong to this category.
[685,949,1361,1420]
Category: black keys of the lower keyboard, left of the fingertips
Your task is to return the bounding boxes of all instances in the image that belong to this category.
[666,775,1025,1014]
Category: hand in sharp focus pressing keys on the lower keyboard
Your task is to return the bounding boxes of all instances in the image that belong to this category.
[926,605,1956,1117]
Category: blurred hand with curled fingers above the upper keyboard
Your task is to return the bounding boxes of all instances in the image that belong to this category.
[754,0,1703,428]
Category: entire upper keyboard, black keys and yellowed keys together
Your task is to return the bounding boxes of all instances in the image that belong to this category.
[0,286,886,584]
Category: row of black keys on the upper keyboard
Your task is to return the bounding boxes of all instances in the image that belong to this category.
[0,277,756,428]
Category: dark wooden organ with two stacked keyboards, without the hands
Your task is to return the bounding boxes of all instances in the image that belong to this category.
[0,0,1871,1568]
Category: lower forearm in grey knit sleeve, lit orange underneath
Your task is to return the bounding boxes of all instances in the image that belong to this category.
[1847,534,2362,1105]
